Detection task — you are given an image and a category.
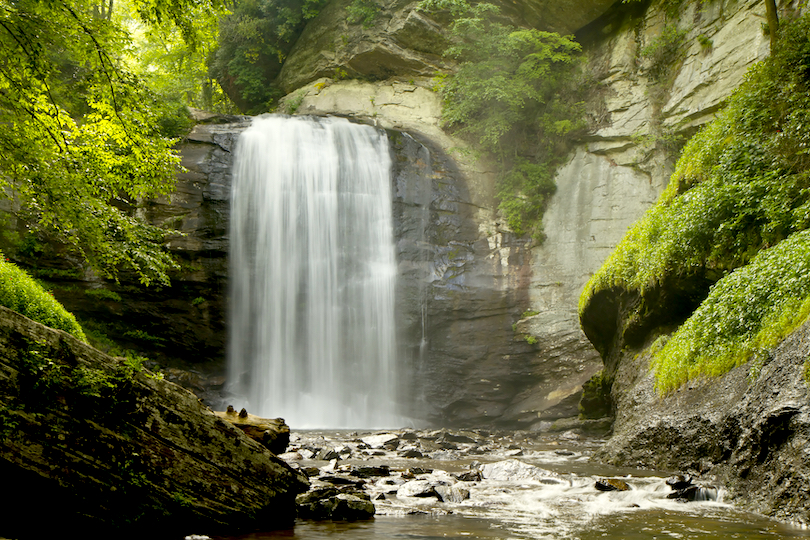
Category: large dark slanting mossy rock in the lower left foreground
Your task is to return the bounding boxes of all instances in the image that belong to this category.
[0,308,308,538]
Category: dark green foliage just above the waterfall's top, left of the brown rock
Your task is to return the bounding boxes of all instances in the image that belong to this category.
[209,0,327,114]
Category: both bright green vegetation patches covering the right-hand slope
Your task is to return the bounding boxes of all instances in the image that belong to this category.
[580,15,810,390]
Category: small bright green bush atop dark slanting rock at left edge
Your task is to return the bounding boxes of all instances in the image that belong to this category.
[0,257,87,342]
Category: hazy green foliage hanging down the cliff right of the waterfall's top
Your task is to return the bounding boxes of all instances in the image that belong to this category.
[420,0,585,239]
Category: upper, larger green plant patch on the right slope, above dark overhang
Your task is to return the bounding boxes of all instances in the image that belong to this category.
[580,16,810,308]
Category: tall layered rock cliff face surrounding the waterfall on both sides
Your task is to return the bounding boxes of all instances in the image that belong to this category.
[4,0,784,427]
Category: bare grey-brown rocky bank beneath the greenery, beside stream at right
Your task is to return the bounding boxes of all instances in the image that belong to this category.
[597,318,810,523]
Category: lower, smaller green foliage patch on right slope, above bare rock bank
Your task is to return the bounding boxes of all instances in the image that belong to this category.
[652,231,810,391]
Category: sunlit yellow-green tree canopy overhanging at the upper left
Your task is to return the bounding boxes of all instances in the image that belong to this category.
[0,0,223,284]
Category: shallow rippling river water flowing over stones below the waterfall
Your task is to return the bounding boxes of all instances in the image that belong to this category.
[211,430,810,540]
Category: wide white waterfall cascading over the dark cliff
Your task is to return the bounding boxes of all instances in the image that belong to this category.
[228,116,401,429]
